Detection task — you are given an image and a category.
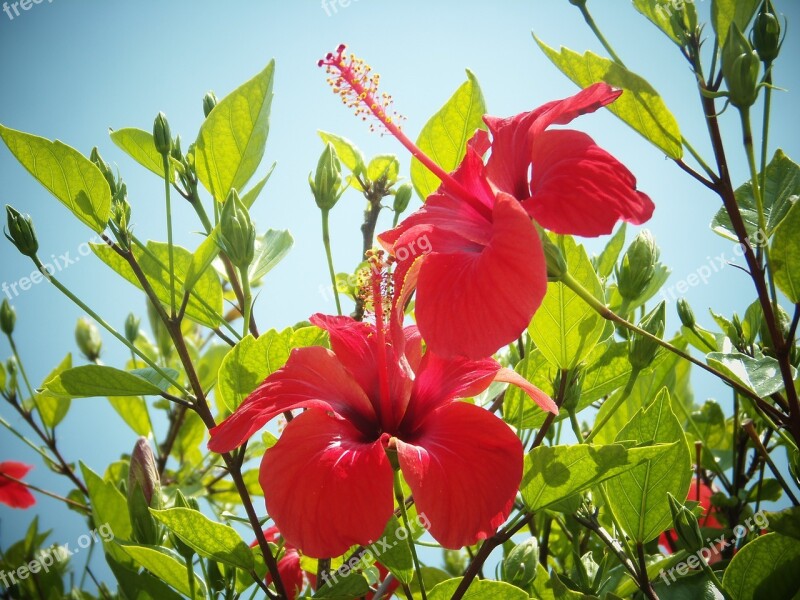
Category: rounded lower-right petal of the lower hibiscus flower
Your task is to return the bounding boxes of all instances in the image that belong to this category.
[397,402,522,549]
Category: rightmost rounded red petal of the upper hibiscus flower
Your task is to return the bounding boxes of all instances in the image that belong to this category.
[523,130,654,236]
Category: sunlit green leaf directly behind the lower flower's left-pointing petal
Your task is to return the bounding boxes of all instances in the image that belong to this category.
[217,329,291,411]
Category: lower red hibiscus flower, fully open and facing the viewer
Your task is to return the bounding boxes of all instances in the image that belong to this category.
[208,270,557,557]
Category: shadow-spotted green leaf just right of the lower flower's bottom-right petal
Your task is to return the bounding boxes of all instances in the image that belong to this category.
[520,444,672,511]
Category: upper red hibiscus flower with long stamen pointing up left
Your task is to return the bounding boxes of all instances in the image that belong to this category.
[320,46,653,358]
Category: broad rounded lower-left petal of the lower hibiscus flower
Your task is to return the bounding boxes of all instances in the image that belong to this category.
[259,408,394,558]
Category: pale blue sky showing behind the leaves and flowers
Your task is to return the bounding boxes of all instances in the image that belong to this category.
[0,0,800,592]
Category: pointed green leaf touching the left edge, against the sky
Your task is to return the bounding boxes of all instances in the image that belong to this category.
[0,125,111,233]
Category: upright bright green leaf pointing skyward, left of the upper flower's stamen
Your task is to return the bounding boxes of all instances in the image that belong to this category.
[195,60,275,202]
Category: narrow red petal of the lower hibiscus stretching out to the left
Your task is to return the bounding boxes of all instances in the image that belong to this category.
[208,346,375,452]
